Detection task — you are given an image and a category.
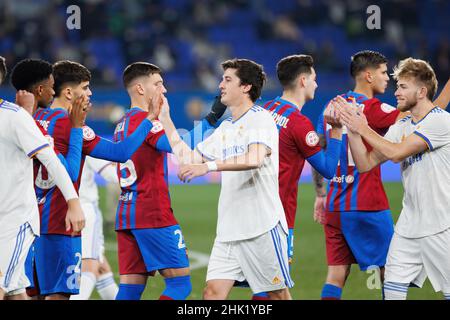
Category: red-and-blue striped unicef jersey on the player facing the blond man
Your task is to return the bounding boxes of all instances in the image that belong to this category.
[317,91,400,212]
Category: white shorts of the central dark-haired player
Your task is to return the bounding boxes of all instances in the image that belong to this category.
[206,224,294,293]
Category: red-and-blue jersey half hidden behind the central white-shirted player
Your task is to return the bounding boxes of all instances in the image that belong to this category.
[264,97,320,229]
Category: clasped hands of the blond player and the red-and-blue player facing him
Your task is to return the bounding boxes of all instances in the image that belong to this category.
[323,96,367,133]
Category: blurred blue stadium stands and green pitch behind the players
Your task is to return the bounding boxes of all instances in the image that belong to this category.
[0,0,450,299]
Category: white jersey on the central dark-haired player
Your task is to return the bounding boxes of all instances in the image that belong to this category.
[197,106,287,242]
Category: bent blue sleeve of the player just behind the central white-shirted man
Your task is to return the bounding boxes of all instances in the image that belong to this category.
[306,138,342,179]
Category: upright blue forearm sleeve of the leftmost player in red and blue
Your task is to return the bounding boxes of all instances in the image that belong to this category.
[58,128,83,182]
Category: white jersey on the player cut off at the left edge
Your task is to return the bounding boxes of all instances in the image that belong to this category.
[0,99,49,235]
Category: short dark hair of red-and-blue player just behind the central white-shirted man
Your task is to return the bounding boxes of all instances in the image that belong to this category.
[277,54,314,89]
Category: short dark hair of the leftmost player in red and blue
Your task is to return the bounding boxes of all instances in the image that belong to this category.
[53,60,91,96]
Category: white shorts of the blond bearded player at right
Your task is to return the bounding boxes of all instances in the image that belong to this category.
[385,229,450,293]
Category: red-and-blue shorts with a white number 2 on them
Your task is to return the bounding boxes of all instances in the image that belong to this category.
[117,225,189,275]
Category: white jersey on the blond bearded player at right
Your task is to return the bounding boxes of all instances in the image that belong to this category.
[385,107,450,238]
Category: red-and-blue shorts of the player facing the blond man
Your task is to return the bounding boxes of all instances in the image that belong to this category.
[324,210,394,271]
